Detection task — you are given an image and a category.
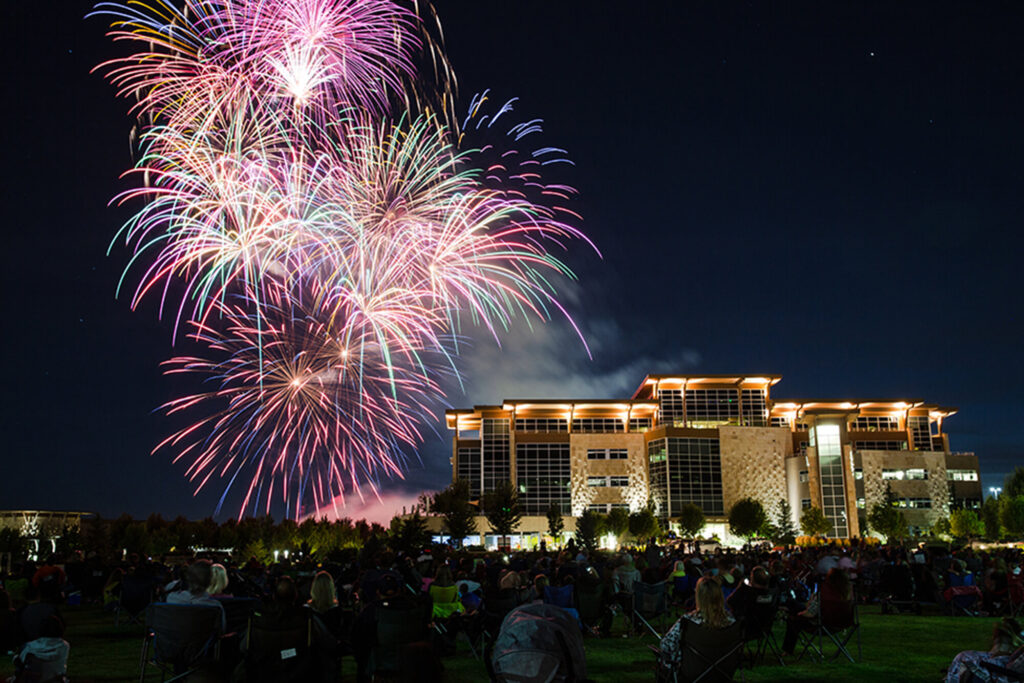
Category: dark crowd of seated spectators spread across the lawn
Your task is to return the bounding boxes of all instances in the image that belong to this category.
[0,541,1024,683]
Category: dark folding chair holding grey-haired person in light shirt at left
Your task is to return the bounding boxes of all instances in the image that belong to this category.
[138,602,221,683]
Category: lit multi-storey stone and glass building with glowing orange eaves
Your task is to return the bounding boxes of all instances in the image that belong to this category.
[445,375,982,538]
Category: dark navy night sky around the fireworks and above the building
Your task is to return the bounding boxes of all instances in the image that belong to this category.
[0,0,1024,517]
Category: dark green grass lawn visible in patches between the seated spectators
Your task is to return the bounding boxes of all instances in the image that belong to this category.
[0,606,995,683]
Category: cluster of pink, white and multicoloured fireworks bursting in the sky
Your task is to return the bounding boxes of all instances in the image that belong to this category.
[97,0,598,515]
